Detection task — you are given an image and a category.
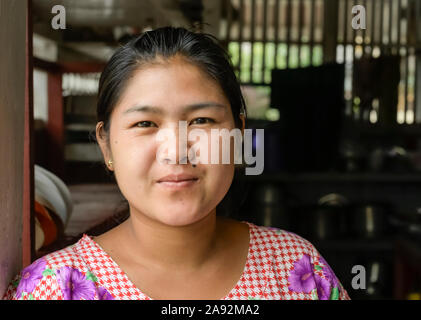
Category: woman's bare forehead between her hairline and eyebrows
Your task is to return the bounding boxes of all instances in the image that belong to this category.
[116,59,229,113]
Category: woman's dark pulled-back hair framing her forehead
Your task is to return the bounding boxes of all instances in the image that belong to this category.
[93,27,246,220]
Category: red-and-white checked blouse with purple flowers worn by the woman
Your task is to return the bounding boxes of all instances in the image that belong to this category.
[4,221,350,300]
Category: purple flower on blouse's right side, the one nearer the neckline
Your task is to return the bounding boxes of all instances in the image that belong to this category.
[288,254,316,293]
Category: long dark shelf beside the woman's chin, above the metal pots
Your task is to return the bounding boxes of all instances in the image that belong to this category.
[240,172,421,183]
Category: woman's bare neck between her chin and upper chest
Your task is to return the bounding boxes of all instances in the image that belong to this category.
[123,210,226,272]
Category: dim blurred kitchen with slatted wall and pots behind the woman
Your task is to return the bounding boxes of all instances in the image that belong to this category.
[26,0,421,299]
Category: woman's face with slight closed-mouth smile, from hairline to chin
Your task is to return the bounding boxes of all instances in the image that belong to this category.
[97,57,243,226]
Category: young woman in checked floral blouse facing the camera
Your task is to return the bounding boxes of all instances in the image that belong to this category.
[6,27,349,300]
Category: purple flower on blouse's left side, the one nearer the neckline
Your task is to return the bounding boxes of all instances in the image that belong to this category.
[57,267,95,300]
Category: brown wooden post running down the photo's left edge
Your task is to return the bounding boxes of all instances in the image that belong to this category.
[0,0,27,296]
